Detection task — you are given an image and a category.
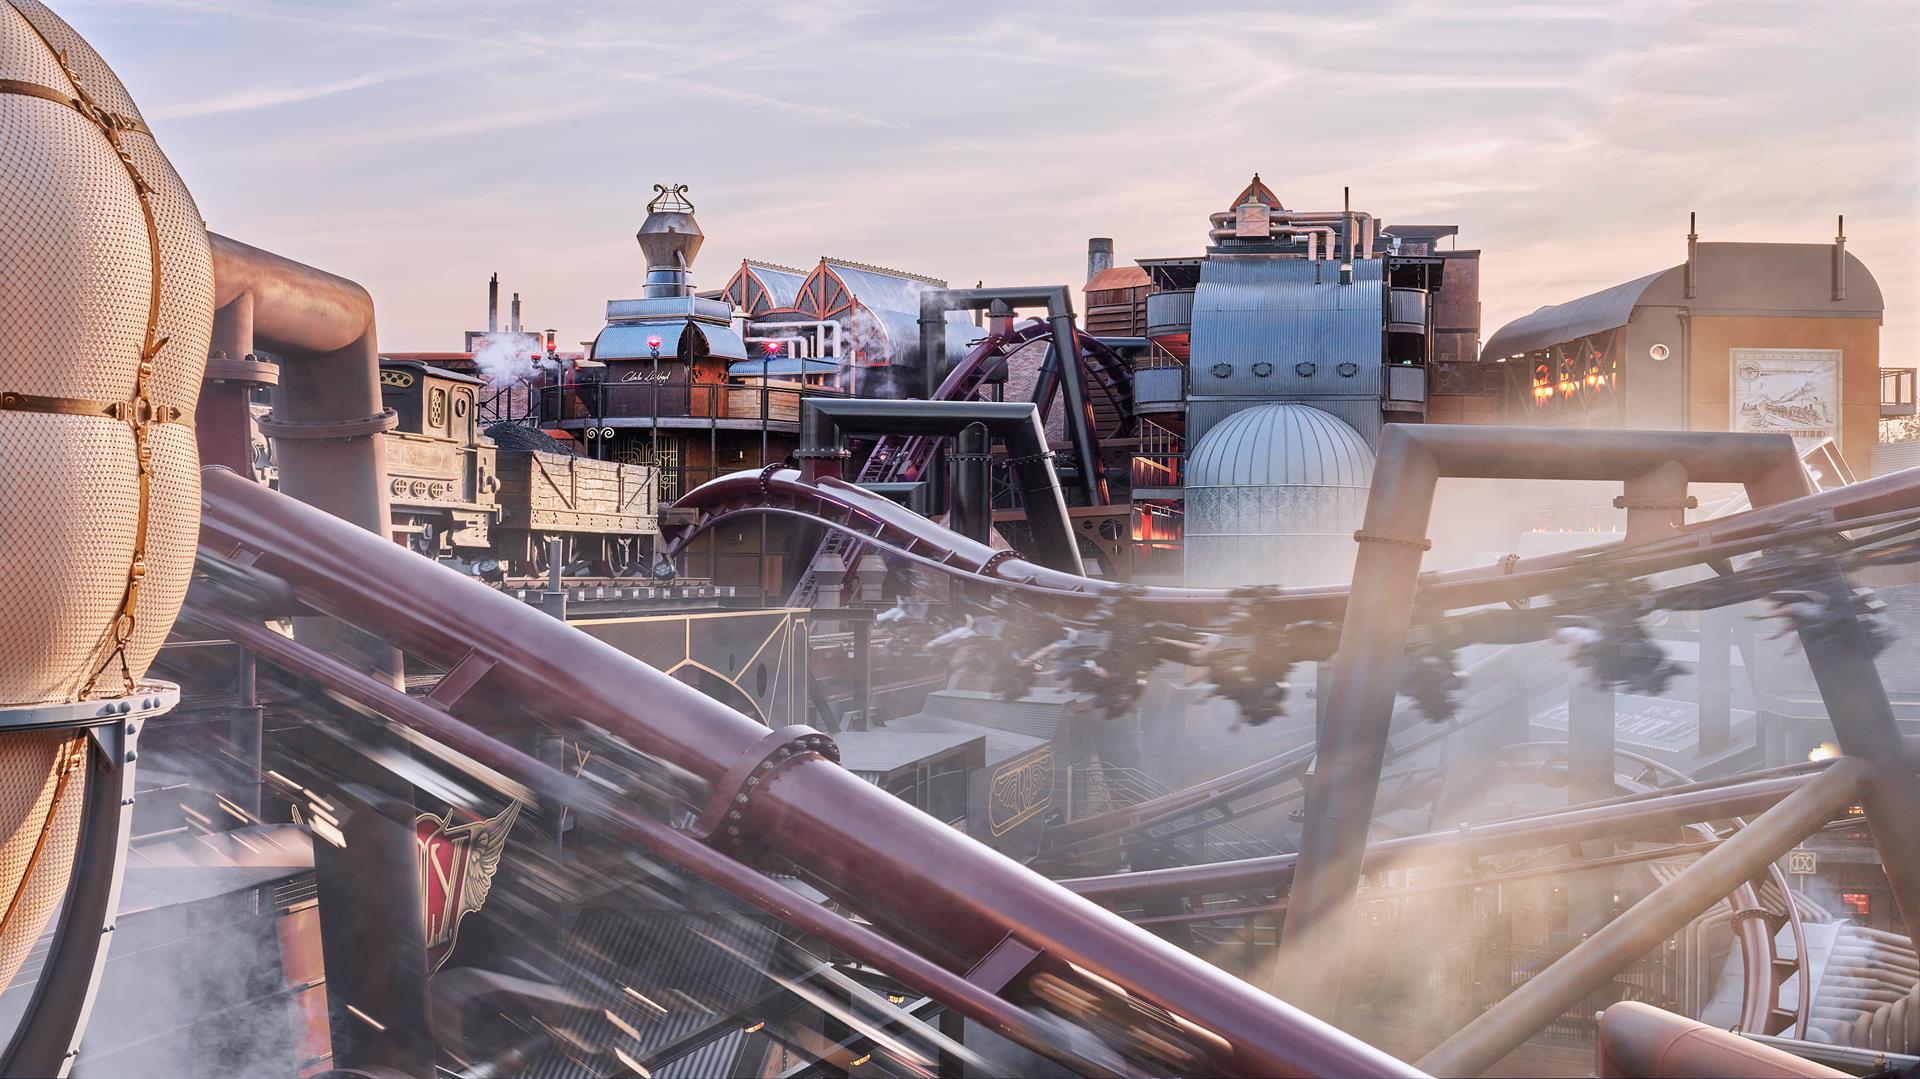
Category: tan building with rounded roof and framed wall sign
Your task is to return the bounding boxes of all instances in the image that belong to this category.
[1484,214,1889,476]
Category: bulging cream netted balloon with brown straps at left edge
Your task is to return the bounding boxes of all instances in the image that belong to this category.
[0,0,213,987]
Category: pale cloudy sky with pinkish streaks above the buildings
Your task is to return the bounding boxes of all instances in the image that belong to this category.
[52,0,1920,365]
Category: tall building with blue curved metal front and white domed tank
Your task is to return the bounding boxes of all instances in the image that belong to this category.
[1087,175,1498,586]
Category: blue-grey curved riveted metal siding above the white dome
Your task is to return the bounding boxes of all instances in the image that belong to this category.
[1188,259,1384,399]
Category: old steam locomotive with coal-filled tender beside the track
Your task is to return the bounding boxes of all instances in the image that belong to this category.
[380,361,660,582]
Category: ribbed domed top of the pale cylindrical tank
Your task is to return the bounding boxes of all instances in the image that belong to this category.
[1187,401,1373,492]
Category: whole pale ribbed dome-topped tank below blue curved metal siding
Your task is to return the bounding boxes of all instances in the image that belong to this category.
[1187,403,1373,587]
